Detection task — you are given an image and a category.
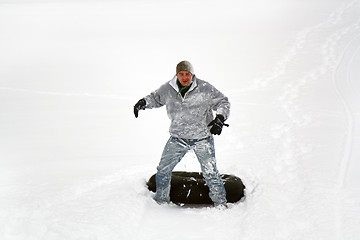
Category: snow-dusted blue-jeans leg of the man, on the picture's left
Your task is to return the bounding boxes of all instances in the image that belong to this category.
[155,137,189,203]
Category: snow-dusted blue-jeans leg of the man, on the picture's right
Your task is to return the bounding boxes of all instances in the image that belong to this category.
[194,136,227,205]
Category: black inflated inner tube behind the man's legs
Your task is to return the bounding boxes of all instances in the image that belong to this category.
[147,171,245,205]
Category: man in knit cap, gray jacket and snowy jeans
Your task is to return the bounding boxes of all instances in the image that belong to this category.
[134,61,230,206]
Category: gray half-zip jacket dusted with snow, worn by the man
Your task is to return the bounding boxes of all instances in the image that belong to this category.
[144,75,230,139]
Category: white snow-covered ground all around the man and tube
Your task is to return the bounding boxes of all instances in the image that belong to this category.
[0,0,360,240]
